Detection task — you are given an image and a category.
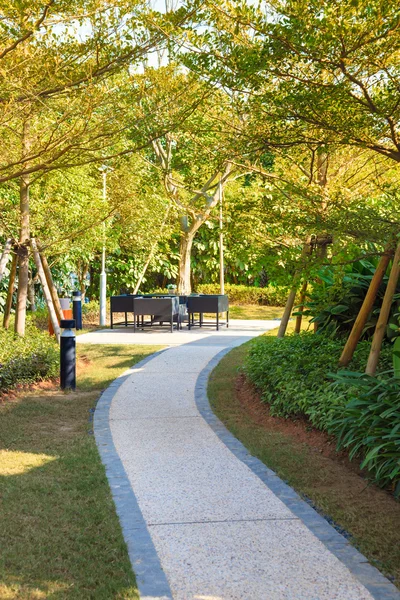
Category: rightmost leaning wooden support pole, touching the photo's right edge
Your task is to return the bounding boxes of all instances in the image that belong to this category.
[365,243,400,375]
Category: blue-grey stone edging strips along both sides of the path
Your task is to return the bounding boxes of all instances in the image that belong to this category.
[94,347,400,600]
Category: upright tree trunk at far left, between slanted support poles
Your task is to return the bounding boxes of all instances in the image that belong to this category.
[14,121,30,335]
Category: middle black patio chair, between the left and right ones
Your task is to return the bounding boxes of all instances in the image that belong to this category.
[133,296,182,333]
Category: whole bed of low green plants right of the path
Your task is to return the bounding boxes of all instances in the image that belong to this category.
[245,332,400,493]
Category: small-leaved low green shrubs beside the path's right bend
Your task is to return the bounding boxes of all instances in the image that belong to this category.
[245,332,391,430]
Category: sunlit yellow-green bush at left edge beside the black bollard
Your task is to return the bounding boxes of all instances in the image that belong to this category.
[0,324,59,392]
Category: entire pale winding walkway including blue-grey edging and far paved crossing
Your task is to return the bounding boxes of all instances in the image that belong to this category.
[90,321,400,600]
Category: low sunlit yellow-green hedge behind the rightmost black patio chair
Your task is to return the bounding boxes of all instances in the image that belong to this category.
[196,283,288,306]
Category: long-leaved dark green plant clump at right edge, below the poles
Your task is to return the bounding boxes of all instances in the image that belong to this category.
[328,371,400,495]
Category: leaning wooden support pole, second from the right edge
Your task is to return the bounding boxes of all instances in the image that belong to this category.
[339,245,393,367]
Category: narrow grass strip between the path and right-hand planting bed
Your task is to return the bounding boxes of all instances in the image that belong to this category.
[208,330,400,585]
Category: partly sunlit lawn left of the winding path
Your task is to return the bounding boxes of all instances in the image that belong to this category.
[0,346,162,600]
